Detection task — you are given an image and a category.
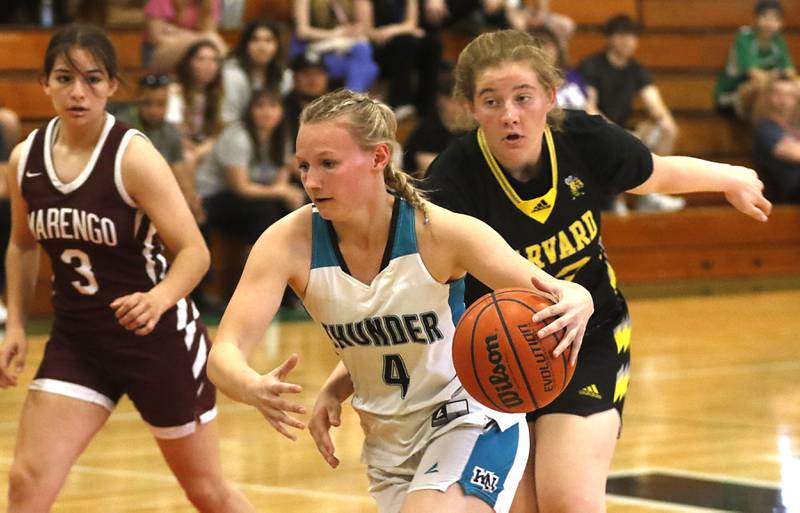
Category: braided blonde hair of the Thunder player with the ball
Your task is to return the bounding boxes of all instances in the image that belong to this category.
[300,89,427,218]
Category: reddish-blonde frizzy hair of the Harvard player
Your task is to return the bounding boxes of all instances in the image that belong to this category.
[453,30,564,128]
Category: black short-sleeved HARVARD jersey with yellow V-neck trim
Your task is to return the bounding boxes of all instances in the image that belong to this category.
[425,111,653,326]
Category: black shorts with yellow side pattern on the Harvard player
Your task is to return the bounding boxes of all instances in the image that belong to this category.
[527,304,631,422]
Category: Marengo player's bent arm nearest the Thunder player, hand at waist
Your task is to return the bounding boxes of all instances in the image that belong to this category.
[111,136,210,335]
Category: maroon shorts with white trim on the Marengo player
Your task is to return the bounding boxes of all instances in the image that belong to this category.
[30,300,217,439]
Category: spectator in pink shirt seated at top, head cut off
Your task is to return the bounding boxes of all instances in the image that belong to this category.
[142,0,227,73]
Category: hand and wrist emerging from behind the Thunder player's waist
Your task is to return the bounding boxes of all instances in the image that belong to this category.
[308,362,353,468]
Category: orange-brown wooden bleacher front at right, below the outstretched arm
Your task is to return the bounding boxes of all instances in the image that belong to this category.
[602,206,800,283]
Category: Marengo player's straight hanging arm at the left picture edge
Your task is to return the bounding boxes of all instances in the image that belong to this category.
[0,144,39,388]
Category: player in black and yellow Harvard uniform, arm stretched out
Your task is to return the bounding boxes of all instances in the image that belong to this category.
[427,31,771,513]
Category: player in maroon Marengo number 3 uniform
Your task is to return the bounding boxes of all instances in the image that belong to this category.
[0,26,253,512]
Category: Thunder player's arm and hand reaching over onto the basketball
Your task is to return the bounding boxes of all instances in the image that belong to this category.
[423,204,594,364]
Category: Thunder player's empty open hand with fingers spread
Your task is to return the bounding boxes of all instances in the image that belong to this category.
[247,354,306,441]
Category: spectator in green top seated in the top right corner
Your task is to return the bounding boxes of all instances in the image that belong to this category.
[714,0,795,121]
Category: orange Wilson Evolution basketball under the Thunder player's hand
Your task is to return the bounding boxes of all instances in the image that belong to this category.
[453,289,575,413]
